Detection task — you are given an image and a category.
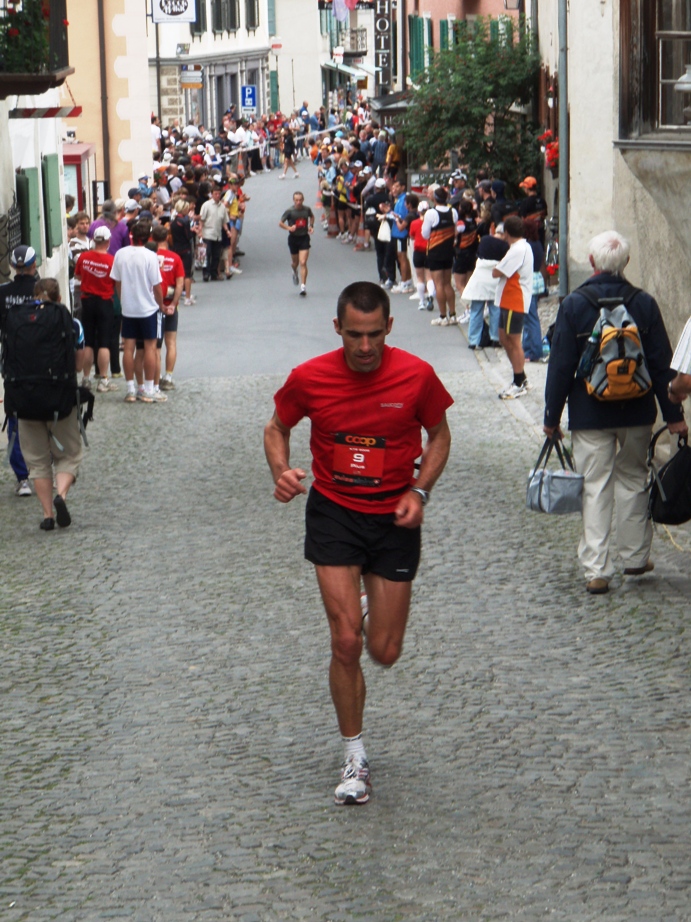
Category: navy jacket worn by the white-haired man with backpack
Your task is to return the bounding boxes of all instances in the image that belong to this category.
[545,273,684,429]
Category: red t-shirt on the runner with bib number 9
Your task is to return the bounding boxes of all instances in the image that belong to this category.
[274,346,453,513]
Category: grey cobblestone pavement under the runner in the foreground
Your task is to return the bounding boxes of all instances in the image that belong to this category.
[0,162,691,922]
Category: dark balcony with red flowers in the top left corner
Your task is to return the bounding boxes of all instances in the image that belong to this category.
[0,0,74,99]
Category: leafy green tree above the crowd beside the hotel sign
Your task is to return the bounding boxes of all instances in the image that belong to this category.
[399,16,540,184]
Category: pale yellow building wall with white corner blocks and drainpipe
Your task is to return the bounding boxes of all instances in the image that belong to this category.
[63,0,152,205]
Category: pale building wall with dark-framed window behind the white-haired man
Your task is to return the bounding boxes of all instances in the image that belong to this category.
[537,0,691,336]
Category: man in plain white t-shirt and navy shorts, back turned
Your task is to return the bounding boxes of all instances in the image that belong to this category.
[110,221,165,403]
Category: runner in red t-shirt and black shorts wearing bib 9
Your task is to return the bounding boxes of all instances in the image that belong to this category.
[264,282,453,805]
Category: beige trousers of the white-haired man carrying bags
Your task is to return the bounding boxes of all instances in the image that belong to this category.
[572,426,653,581]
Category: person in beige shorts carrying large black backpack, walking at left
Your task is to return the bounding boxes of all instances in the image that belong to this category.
[2,279,84,531]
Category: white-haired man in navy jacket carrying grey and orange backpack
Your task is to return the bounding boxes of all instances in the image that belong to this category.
[544,231,688,595]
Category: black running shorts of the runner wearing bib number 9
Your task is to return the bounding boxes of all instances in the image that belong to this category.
[305,488,420,583]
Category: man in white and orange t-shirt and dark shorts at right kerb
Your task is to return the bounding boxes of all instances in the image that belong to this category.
[492,215,533,400]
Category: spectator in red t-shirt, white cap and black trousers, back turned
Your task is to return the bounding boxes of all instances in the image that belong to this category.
[74,225,118,393]
